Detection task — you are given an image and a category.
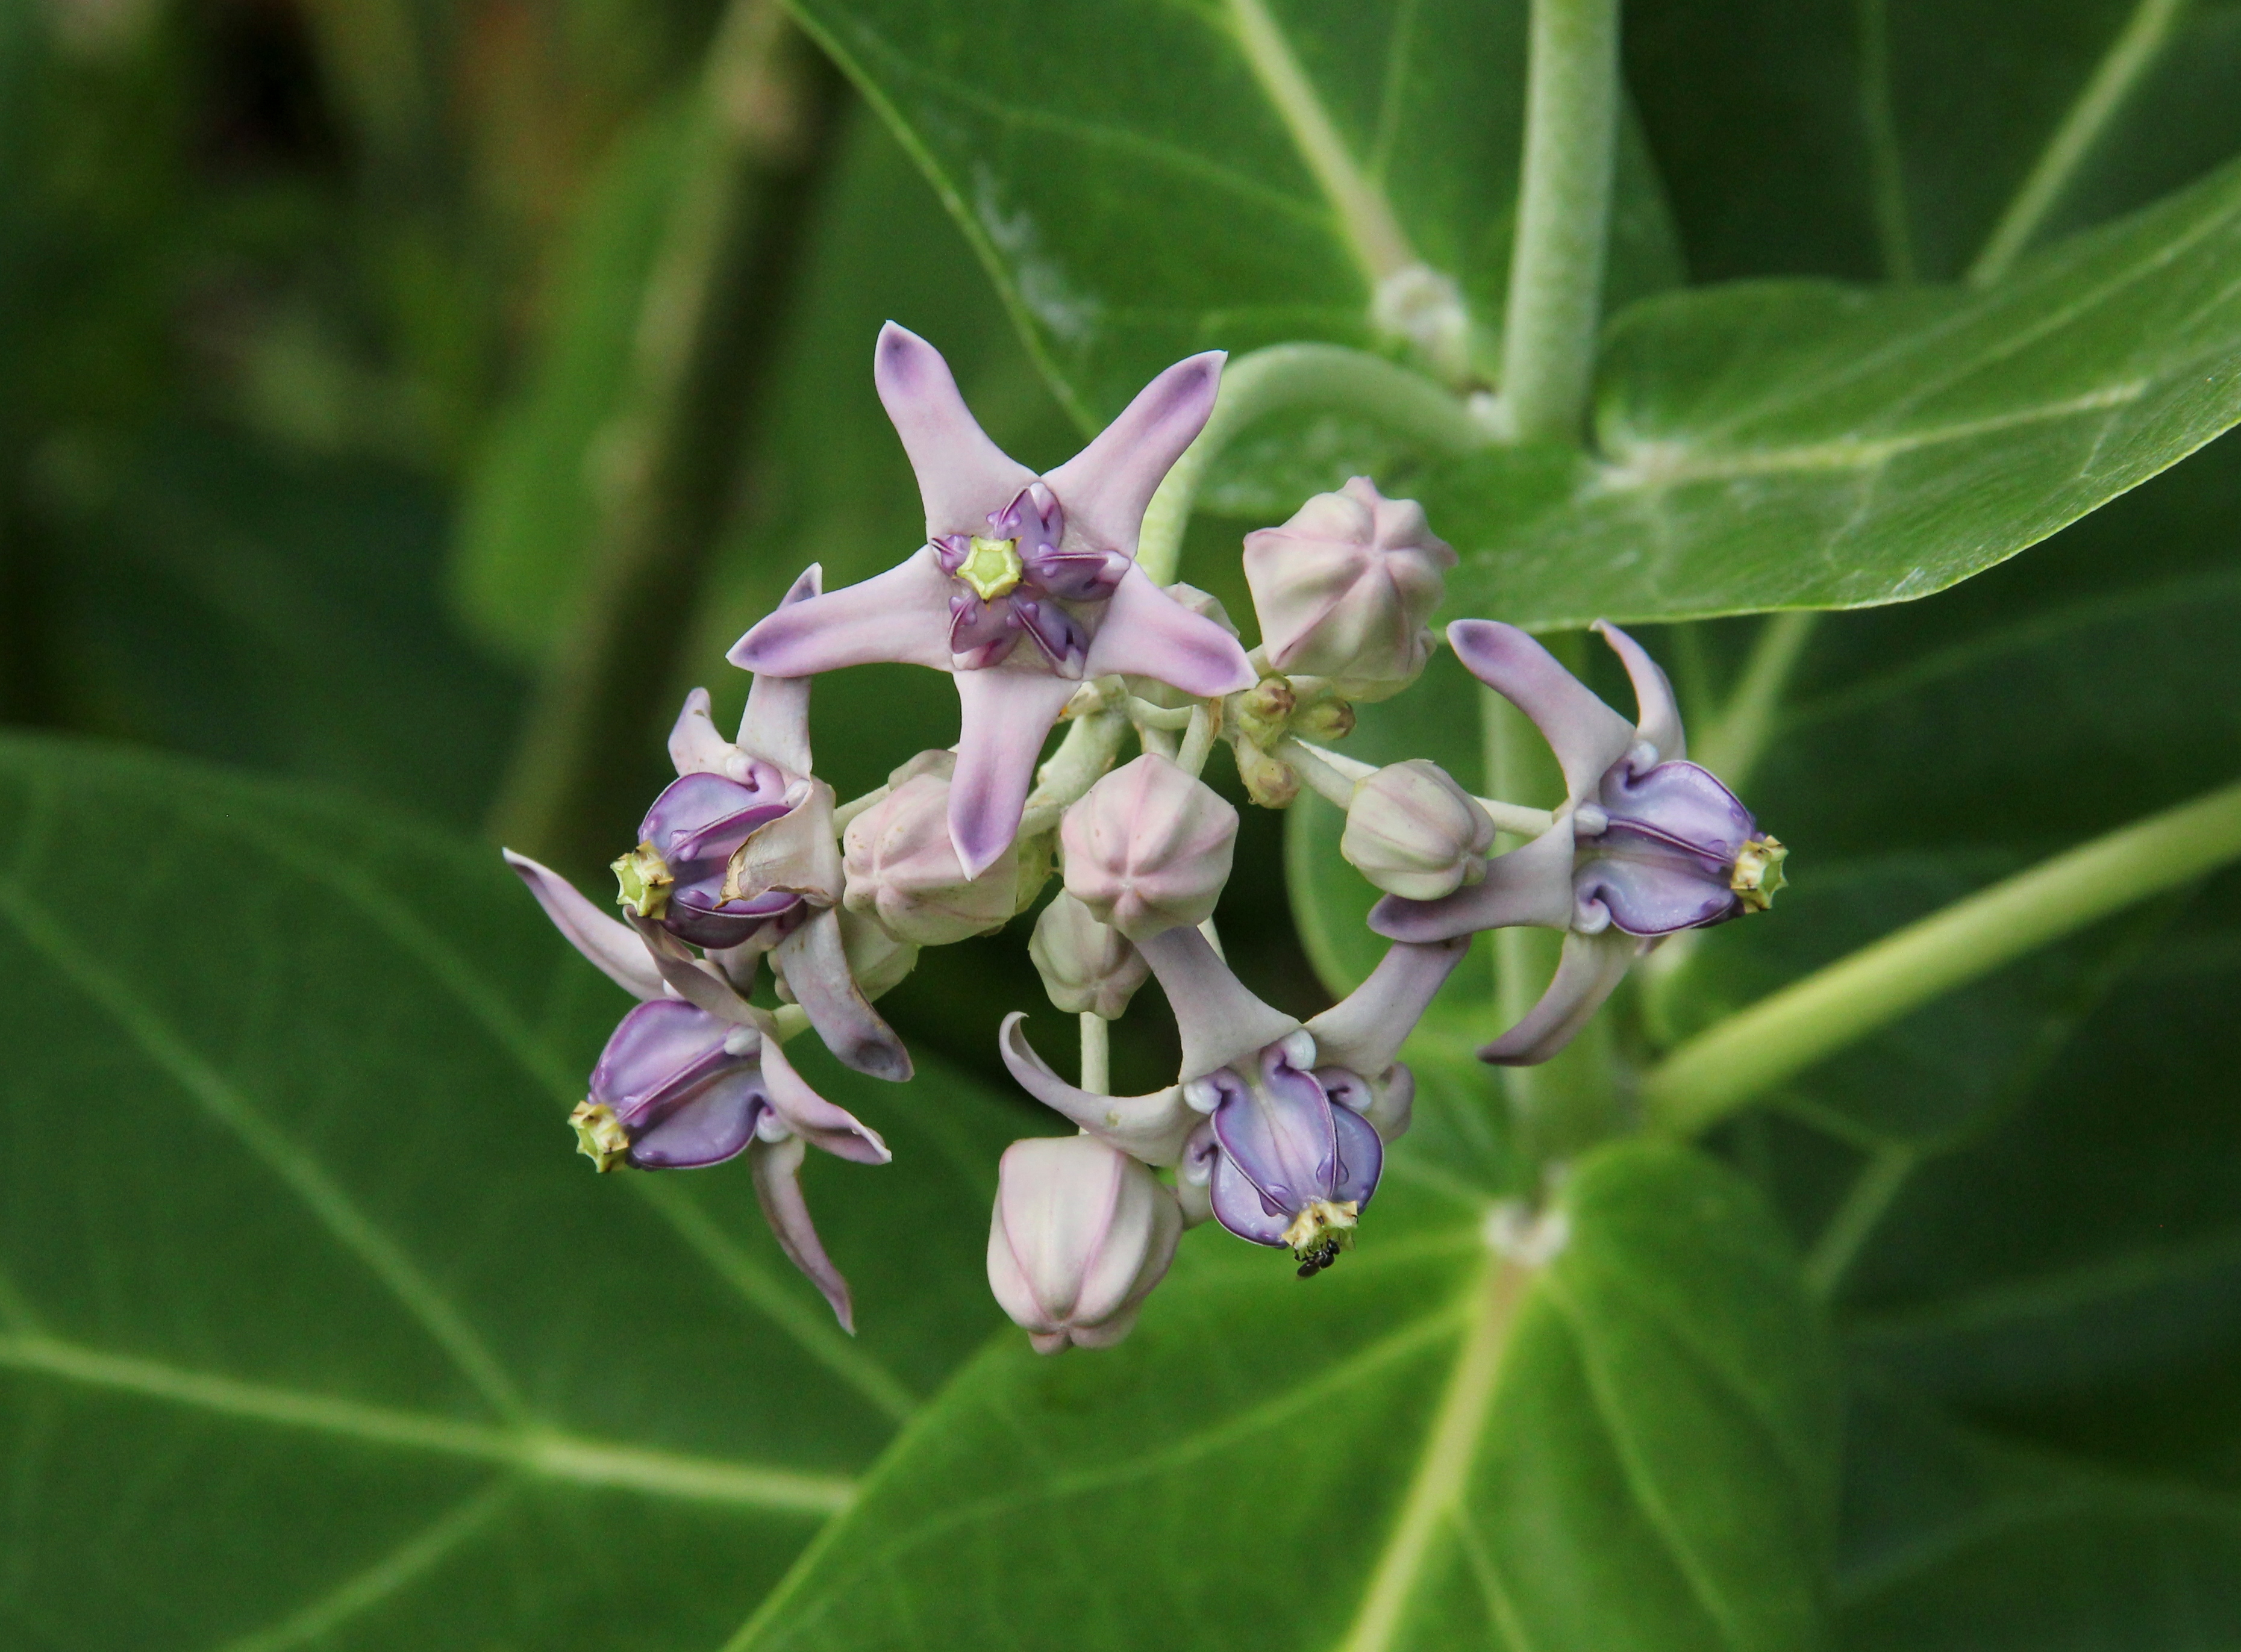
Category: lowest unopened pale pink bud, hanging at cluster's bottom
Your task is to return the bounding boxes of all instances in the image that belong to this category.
[989,1136,1183,1354]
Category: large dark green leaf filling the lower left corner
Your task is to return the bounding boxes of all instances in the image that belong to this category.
[0,737,1015,1652]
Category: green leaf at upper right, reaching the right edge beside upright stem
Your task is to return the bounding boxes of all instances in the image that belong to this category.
[1412,166,2241,630]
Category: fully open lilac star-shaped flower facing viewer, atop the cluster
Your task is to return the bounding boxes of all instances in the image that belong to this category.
[731,320,1252,876]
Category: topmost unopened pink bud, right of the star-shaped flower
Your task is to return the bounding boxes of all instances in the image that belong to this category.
[1246,475,1454,699]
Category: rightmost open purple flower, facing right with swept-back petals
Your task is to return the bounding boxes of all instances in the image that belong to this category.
[1369,619,1789,1065]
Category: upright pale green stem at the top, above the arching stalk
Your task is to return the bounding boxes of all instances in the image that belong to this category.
[1501,0,1618,444]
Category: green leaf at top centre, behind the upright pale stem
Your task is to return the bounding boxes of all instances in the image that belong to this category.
[780,0,1678,426]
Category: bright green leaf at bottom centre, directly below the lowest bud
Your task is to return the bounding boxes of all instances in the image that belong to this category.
[733,1145,1836,1652]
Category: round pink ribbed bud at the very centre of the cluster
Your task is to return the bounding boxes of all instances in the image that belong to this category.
[1060,753,1237,941]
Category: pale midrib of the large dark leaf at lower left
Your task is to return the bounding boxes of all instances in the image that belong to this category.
[0,1336,856,1515]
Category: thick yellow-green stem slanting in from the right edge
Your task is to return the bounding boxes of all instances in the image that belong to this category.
[1643,785,2241,1134]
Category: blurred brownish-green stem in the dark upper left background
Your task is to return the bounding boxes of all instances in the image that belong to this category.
[491,0,836,870]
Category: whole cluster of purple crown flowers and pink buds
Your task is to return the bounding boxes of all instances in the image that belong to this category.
[507,323,1786,1351]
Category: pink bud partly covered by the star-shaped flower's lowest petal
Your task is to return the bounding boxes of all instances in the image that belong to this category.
[845,773,1020,946]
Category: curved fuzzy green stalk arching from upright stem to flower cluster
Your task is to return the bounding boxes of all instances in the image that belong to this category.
[1136,345,1488,585]
